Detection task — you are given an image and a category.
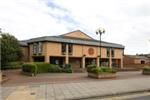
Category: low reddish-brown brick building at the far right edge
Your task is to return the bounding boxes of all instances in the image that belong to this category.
[123,55,150,67]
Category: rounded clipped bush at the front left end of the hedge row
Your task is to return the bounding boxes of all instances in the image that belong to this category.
[22,63,37,75]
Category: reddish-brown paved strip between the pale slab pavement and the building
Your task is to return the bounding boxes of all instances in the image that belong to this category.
[2,70,149,86]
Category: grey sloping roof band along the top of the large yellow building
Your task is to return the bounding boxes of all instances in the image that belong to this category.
[20,35,124,49]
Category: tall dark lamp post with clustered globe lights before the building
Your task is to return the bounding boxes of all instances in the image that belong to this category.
[96,28,105,66]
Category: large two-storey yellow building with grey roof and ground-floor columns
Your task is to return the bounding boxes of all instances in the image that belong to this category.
[20,30,124,69]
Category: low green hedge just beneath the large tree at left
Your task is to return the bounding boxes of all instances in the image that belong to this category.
[5,62,23,69]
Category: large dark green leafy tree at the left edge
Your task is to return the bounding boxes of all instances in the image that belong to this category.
[0,31,22,69]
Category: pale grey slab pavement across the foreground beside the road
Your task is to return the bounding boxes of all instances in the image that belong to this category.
[1,76,150,100]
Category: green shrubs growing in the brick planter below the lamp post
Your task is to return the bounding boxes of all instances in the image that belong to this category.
[87,65,116,74]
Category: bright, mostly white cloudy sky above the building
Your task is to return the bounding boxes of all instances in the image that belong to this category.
[0,0,150,54]
